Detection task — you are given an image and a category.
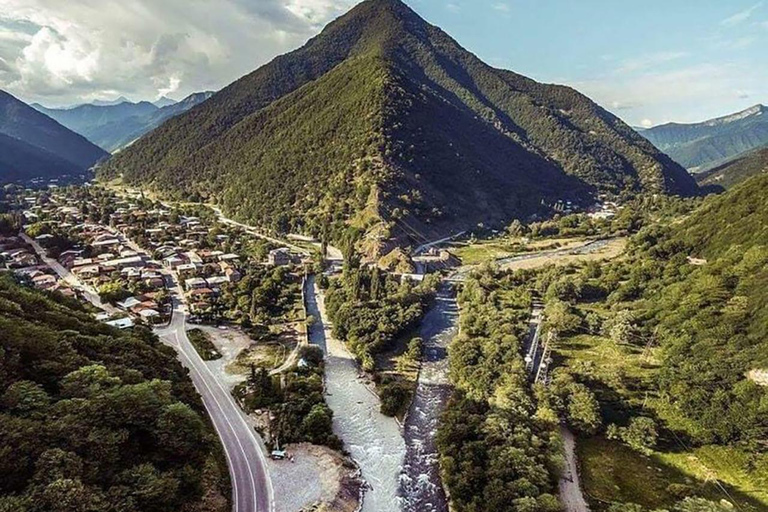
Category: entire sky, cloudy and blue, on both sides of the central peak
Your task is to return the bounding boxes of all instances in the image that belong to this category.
[0,0,768,125]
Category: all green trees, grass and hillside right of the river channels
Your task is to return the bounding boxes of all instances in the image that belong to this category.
[440,176,768,511]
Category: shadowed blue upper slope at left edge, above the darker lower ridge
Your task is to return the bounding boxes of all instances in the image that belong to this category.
[0,91,107,172]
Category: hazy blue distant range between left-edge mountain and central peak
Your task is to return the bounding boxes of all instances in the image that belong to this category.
[32,92,213,152]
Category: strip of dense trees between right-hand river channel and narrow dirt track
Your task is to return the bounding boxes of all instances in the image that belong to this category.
[437,269,563,512]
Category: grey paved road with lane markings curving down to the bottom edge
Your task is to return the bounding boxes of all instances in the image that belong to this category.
[156,277,274,512]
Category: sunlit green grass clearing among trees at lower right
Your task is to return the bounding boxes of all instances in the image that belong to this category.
[555,335,768,511]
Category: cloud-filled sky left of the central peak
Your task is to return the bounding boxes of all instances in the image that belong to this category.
[0,0,357,105]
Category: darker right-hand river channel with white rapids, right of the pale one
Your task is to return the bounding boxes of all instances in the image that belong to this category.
[400,283,459,512]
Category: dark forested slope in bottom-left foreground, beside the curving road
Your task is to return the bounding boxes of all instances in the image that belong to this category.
[0,275,229,512]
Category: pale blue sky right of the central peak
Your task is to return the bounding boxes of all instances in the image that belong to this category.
[409,0,768,125]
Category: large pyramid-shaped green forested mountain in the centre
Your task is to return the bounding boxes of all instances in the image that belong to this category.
[103,0,696,250]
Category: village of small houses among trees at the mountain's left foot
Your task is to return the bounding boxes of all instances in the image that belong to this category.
[0,187,312,329]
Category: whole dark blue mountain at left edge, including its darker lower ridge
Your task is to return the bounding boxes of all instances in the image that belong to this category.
[0,91,108,182]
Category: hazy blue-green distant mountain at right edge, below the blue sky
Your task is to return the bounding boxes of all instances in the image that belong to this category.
[640,105,768,172]
